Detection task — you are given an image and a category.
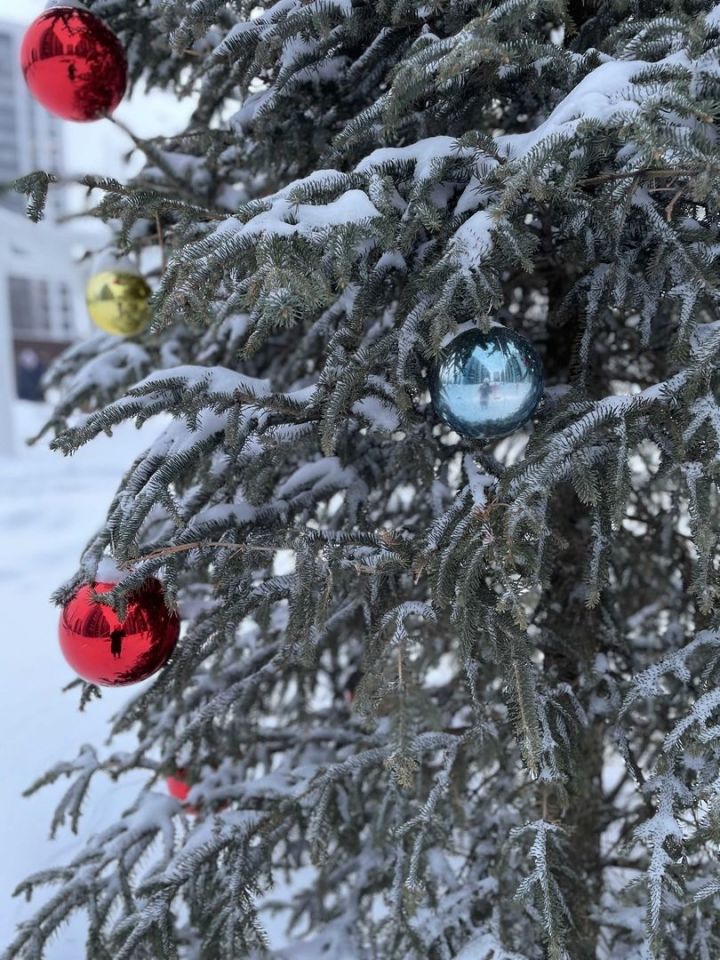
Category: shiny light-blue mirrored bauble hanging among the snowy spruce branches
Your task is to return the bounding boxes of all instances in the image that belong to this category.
[430,326,543,440]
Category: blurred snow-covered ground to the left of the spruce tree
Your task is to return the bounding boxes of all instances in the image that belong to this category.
[0,403,158,960]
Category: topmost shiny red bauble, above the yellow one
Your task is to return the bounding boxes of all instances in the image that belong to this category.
[20,6,127,122]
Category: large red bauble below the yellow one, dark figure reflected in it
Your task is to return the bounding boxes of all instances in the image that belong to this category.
[60,579,180,687]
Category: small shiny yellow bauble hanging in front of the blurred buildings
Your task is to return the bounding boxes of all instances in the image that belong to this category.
[85,270,152,337]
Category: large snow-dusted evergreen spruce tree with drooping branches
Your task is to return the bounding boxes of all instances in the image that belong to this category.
[4,0,720,960]
